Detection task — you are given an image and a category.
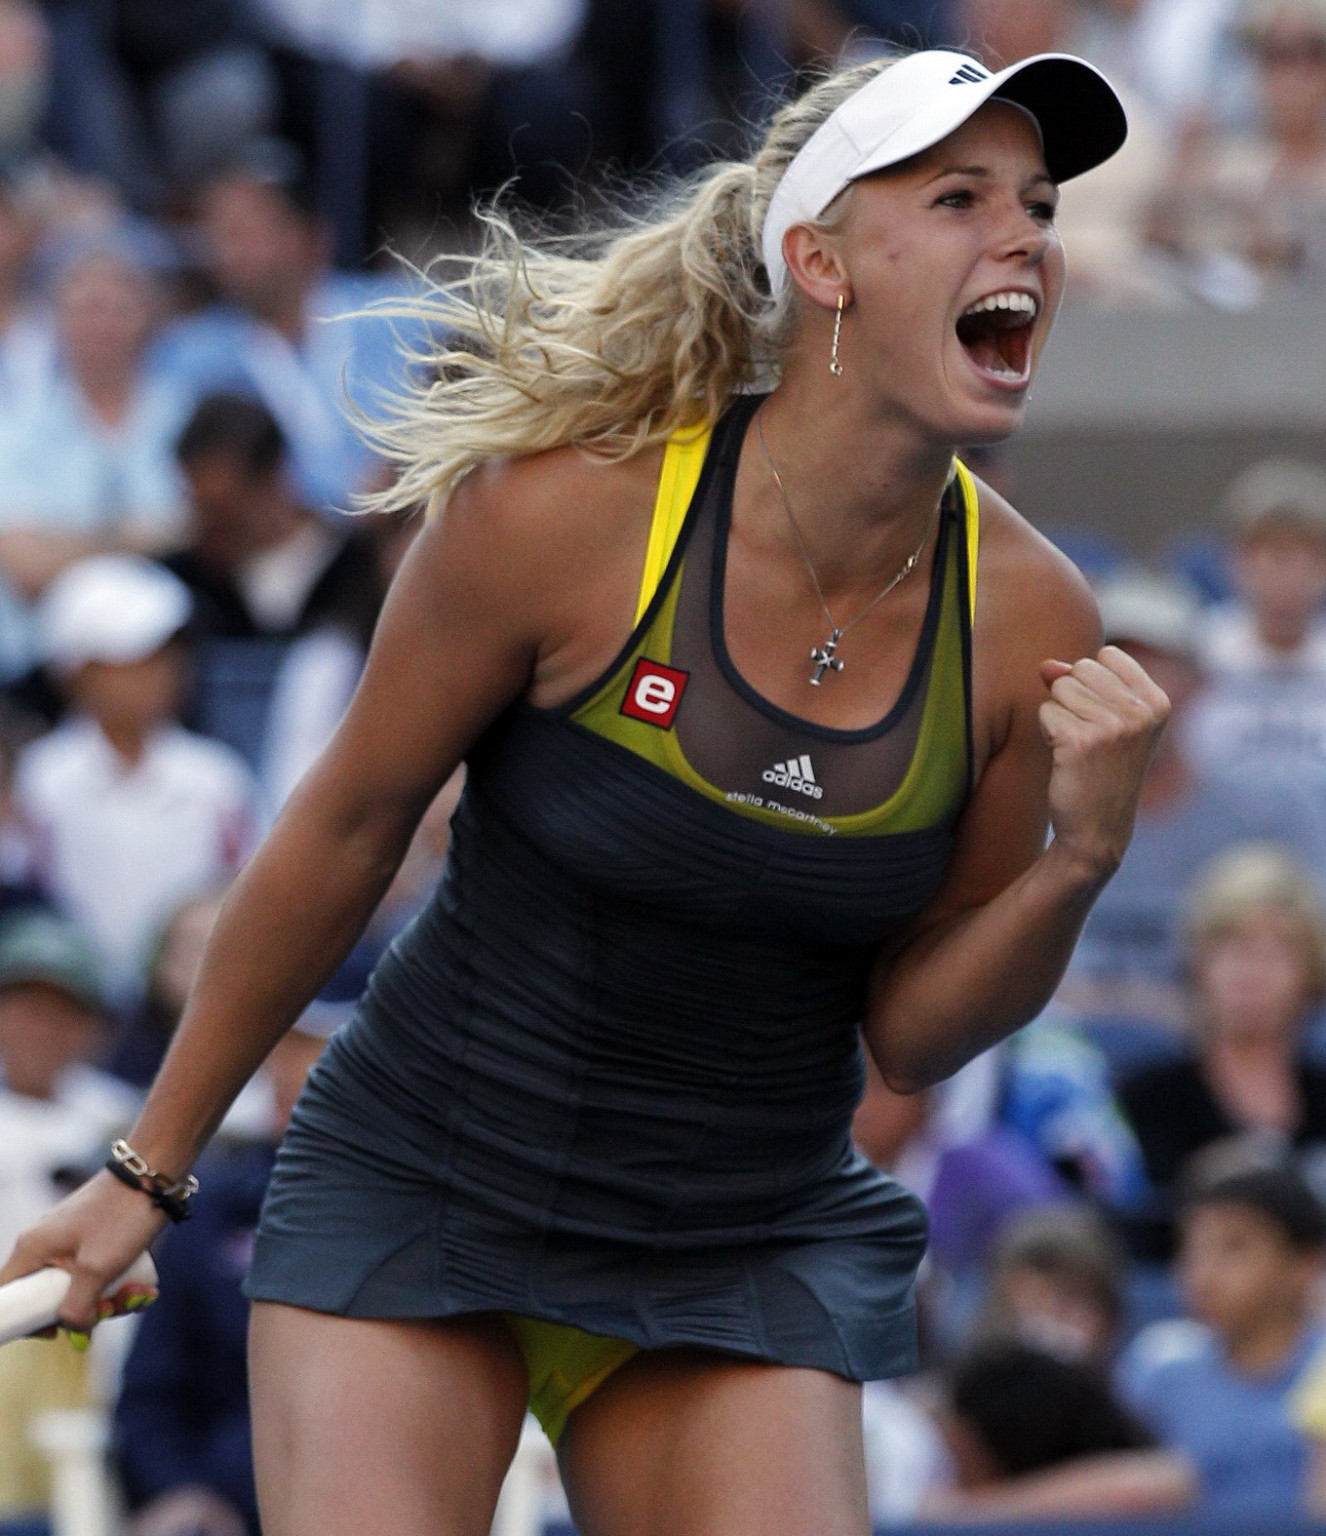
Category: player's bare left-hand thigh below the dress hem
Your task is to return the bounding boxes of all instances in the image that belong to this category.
[249,1303,527,1536]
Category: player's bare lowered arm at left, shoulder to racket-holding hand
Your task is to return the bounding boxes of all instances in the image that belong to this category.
[0,451,586,1327]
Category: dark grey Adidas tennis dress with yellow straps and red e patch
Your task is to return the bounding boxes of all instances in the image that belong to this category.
[247,399,974,1379]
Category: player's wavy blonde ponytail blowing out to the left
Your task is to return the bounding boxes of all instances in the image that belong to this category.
[364,58,894,511]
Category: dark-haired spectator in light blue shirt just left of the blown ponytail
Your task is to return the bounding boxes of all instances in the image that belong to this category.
[164,148,401,500]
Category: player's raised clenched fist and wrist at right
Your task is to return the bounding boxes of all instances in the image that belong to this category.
[1040,645,1169,874]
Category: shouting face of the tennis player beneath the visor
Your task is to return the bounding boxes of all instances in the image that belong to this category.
[836,101,1063,445]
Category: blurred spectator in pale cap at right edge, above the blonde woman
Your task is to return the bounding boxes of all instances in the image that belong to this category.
[1185,459,1326,797]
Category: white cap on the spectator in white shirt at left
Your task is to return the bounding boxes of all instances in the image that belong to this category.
[37,554,194,676]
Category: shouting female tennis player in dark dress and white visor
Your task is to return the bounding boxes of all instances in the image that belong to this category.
[3,42,1166,1536]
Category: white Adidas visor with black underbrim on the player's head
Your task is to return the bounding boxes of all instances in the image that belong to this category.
[762,48,1128,295]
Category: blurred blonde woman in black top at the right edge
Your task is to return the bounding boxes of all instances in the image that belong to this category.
[1119,843,1326,1258]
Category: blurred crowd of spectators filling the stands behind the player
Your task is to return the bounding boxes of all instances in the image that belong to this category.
[0,0,1326,1536]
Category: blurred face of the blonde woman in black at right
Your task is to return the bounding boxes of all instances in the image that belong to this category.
[1195,908,1311,1040]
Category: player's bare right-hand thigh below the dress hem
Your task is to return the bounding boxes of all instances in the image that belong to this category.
[559,1350,870,1536]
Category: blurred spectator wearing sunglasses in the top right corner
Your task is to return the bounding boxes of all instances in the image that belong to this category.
[1152,0,1326,309]
